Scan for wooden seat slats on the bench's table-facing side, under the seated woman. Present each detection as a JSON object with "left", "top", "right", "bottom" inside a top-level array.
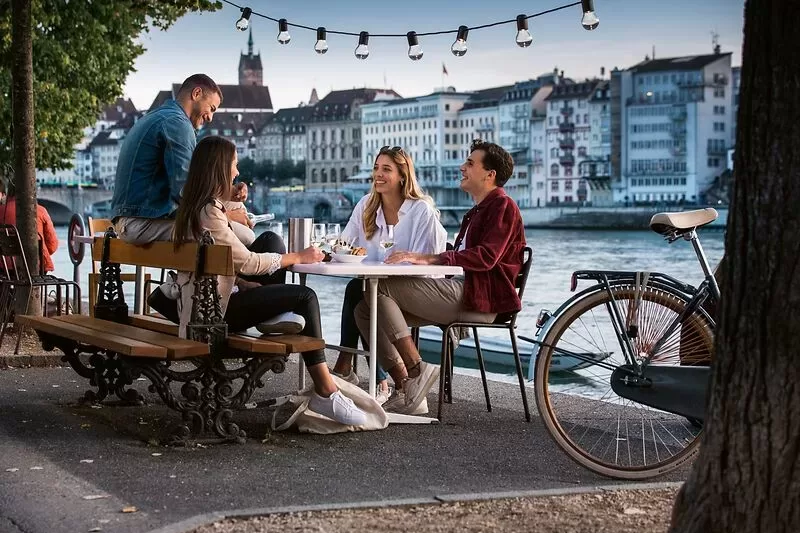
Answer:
[{"left": 131, "top": 315, "right": 325, "bottom": 354}]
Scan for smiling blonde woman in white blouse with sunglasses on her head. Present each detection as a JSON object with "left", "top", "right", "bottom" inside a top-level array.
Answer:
[{"left": 333, "top": 146, "right": 447, "bottom": 403}]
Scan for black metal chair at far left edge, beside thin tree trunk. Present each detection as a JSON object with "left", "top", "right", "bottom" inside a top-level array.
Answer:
[{"left": 0, "top": 224, "right": 81, "bottom": 354}]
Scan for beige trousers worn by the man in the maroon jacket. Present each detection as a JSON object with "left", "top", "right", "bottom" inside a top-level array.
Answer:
[{"left": 355, "top": 277, "right": 497, "bottom": 370}]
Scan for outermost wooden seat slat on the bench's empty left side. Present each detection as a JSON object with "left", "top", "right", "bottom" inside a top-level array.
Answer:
[{"left": 16, "top": 315, "right": 167, "bottom": 359}]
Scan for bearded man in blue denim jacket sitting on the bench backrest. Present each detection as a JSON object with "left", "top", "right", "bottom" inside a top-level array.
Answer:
[{"left": 111, "top": 74, "right": 222, "bottom": 244}]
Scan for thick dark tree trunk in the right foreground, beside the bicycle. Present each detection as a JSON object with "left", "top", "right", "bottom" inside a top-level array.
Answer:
[{"left": 671, "top": 0, "right": 800, "bottom": 533}]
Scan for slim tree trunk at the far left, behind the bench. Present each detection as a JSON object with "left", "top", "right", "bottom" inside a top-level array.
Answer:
[{"left": 11, "top": 0, "right": 39, "bottom": 282}]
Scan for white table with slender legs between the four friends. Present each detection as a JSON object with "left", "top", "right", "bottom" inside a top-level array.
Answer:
[{"left": 289, "top": 261, "right": 464, "bottom": 423}]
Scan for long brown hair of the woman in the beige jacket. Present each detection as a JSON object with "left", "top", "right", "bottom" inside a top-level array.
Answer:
[{"left": 172, "top": 136, "right": 236, "bottom": 246}]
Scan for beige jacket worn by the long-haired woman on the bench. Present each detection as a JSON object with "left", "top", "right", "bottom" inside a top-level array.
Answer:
[{"left": 178, "top": 200, "right": 281, "bottom": 338}]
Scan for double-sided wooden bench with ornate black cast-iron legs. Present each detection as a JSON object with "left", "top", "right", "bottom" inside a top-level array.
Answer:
[{"left": 16, "top": 230, "right": 325, "bottom": 443}]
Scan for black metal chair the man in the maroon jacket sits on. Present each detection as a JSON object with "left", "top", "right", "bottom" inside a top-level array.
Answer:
[{"left": 436, "top": 246, "right": 533, "bottom": 422}]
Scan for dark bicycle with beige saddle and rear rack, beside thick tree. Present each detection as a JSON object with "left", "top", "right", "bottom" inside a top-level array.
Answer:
[{"left": 521, "top": 209, "right": 719, "bottom": 479}]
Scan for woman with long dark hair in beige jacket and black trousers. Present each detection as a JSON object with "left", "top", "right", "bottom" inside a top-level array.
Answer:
[{"left": 173, "top": 136, "right": 366, "bottom": 426}]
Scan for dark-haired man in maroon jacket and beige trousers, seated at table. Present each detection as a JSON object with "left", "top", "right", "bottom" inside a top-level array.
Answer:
[{"left": 355, "top": 140, "right": 525, "bottom": 414}]
